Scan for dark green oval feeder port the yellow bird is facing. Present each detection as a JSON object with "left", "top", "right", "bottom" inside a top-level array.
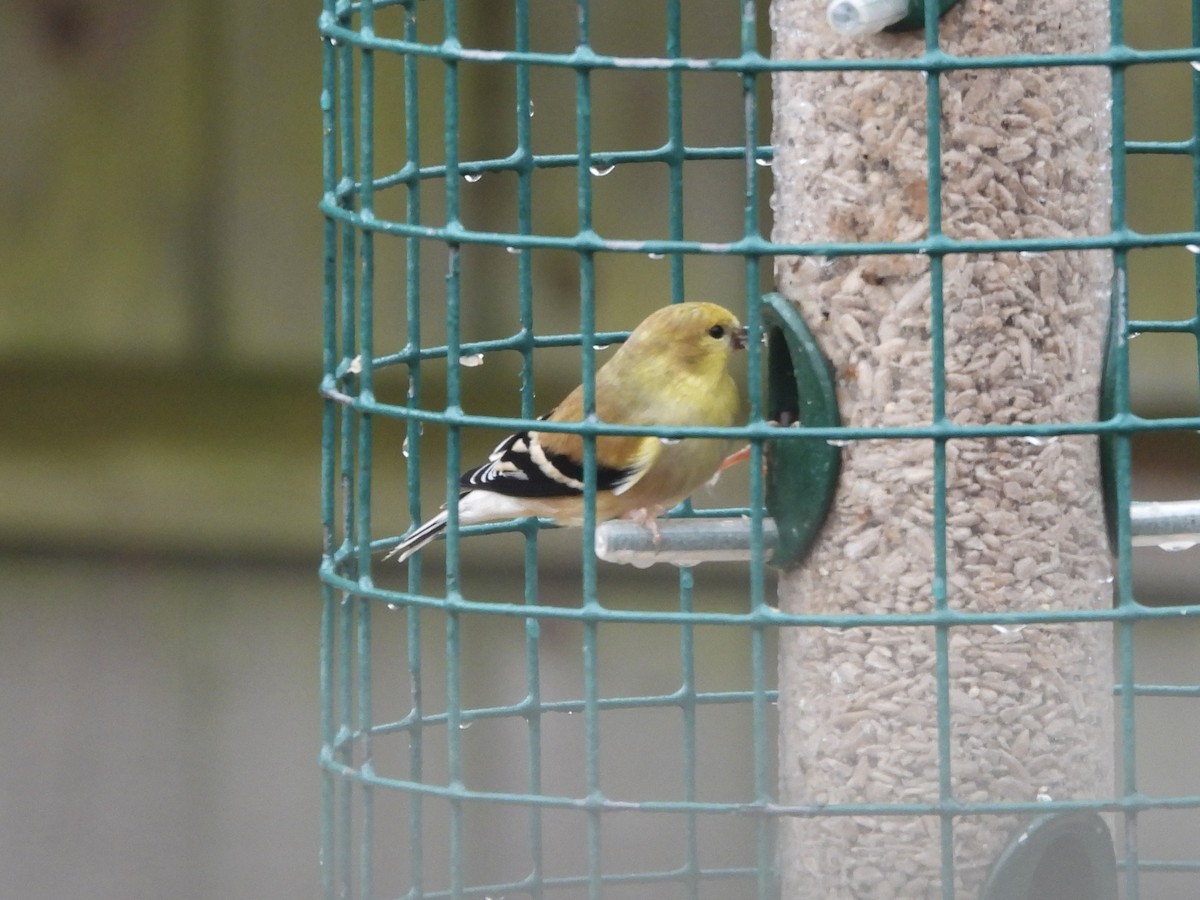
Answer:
[{"left": 762, "top": 294, "right": 841, "bottom": 569}]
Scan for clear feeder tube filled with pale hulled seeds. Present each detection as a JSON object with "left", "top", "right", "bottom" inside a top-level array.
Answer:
[{"left": 772, "top": 0, "right": 1114, "bottom": 898}]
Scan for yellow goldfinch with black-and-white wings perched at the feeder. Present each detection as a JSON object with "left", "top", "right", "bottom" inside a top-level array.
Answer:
[{"left": 388, "top": 302, "right": 746, "bottom": 562}]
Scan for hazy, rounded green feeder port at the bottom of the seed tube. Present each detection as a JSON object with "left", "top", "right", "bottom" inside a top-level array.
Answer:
[{"left": 983, "top": 812, "right": 1117, "bottom": 900}]
